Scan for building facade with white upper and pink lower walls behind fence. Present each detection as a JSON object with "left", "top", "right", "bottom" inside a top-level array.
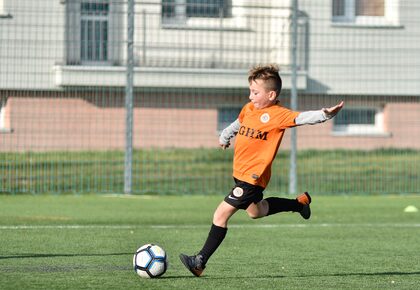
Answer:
[{"left": 0, "top": 0, "right": 420, "bottom": 152}]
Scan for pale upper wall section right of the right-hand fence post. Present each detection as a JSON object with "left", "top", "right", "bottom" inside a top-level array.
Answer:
[{"left": 299, "top": 0, "right": 420, "bottom": 95}]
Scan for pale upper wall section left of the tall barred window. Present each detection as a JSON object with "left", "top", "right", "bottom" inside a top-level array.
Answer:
[{"left": 0, "top": 0, "right": 65, "bottom": 89}]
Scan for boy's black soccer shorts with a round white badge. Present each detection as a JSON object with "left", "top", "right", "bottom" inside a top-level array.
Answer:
[{"left": 224, "top": 178, "right": 264, "bottom": 209}]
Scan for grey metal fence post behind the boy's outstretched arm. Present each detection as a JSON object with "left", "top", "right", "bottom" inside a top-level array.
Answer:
[{"left": 289, "top": 0, "right": 298, "bottom": 194}]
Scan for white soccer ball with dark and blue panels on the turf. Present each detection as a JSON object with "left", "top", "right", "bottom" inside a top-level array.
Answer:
[{"left": 133, "top": 244, "right": 168, "bottom": 278}]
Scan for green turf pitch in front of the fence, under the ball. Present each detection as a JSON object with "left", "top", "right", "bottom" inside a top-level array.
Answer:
[{"left": 0, "top": 195, "right": 420, "bottom": 289}]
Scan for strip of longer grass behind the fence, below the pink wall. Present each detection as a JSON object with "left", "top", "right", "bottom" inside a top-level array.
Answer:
[{"left": 0, "top": 149, "right": 420, "bottom": 194}]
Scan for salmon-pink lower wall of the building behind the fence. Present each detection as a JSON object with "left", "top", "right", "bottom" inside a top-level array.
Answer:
[{"left": 0, "top": 96, "right": 420, "bottom": 152}]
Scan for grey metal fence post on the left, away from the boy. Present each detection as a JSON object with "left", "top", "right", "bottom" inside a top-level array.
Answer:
[{"left": 124, "top": 0, "right": 134, "bottom": 194}]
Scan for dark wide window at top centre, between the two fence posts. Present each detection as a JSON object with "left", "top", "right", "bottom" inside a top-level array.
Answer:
[{"left": 162, "top": 0, "right": 232, "bottom": 23}]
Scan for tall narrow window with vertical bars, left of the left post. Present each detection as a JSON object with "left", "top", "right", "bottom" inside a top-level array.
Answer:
[{"left": 80, "top": 1, "right": 109, "bottom": 62}]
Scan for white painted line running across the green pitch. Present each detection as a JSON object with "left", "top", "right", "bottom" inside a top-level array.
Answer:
[{"left": 0, "top": 223, "right": 420, "bottom": 230}]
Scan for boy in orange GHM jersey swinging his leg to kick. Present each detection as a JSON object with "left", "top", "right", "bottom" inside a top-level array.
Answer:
[{"left": 180, "top": 65, "right": 344, "bottom": 277}]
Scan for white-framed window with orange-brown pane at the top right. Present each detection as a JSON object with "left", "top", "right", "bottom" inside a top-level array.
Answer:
[{"left": 332, "top": 0, "right": 399, "bottom": 25}]
